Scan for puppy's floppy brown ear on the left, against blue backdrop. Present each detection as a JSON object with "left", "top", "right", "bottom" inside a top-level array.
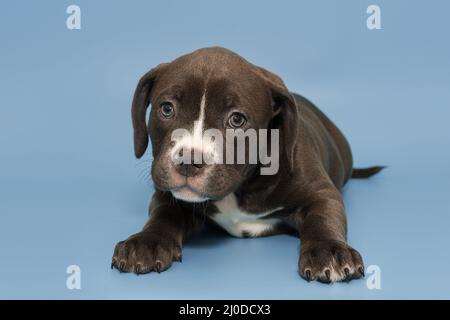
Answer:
[{"left": 131, "top": 64, "right": 166, "bottom": 158}]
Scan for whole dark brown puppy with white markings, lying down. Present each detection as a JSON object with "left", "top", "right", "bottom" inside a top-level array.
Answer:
[{"left": 112, "top": 48, "right": 381, "bottom": 282}]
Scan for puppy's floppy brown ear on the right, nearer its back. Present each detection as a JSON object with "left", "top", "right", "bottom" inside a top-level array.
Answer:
[{"left": 256, "top": 67, "right": 300, "bottom": 173}]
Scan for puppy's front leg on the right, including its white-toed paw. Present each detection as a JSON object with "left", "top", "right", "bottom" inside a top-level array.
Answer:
[{"left": 298, "top": 179, "right": 364, "bottom": 282}]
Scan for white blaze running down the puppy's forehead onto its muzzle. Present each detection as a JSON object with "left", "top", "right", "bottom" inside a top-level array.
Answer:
[{"left": 171, "top": 91, "right": 220, "bottom": 163}]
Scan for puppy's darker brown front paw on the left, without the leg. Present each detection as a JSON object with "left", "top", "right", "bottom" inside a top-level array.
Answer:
[{"left": 111, "top": 232, "right": 181, "bottom": 274}]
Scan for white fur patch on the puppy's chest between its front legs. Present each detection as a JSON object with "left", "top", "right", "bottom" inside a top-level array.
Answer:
[{"left": 211, "top": 194, "right": 282, "bottom": 237}]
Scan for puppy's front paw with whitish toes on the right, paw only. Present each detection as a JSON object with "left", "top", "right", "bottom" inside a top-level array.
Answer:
[{"left": 299, "top": 240, "right": 364, "bottom": 283}]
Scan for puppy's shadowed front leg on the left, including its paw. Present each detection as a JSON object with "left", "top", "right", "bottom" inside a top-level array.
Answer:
[{"left": 111, "top": 191, "right": 203, "bottom": 274}]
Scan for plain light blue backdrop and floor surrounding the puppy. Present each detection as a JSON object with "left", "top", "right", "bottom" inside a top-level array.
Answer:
[{"left": 0, "top": 0, "right": 450, "bottom": 299}]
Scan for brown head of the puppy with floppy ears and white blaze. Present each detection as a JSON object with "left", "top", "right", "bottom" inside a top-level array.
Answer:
[{"left": 132, "top": 48, "right": 298, "bottom": 202}]
